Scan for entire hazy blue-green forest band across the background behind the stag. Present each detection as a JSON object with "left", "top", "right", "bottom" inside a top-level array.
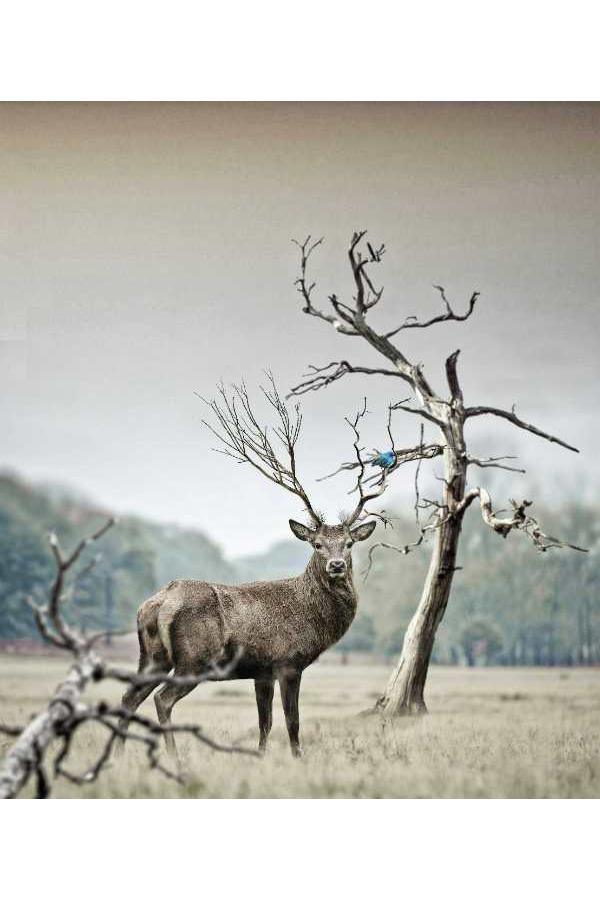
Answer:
[{"left": 0, "top": 474, "right": 600, "bottom": 666}]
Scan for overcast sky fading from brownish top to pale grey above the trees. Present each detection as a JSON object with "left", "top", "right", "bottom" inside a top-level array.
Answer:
[{"left": 0, "top": 103, "right": 600, "bottom": 554}]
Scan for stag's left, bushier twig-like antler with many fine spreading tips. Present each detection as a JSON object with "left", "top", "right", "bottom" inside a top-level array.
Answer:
[{"left": 197, "top": 372, "right": 323, "bottom": 526}]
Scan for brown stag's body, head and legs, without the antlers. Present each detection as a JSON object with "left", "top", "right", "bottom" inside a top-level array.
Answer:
[{"left": 123, "top": 521, "right": 374, "bottom": 755}]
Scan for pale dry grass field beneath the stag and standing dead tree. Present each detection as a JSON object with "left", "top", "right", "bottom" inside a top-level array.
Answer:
[{"left": 0, "top": 655, "right": 600, "bottom": 798}]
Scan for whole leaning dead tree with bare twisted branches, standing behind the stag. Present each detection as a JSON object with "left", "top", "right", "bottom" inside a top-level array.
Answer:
[{"left": 291, "top": 231, "right": 582, "bottom": 715}]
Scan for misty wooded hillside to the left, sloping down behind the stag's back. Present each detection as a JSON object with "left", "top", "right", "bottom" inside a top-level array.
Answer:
[{"left": 0, "top": 475, "right": 236, "bottom": 640}]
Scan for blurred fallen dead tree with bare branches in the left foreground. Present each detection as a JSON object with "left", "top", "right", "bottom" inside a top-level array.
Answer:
[{"left": 0, "top": 519, "right": 254, "bottom": 800}]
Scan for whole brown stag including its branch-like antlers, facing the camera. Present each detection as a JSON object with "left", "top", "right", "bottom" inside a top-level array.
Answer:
[{"left": 122, "top": 377, "right": 387, "bottom": 756}]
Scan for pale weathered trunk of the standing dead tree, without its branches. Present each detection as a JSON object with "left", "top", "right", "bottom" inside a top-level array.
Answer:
[{"left": 375, "top": 420, "right": 466, "bottom": 716}]
